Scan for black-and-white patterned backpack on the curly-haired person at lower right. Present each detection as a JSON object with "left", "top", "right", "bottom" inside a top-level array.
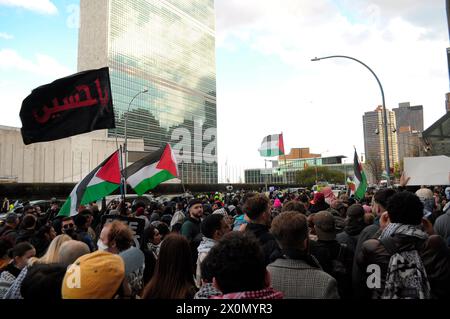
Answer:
[{"left": 380, "top": 239, "right": 431, "bottom": 299}]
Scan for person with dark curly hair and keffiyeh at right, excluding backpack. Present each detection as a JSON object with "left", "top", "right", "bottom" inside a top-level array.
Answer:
[{"left": 355, "top": 191, "right": 450, "bottom": 299}]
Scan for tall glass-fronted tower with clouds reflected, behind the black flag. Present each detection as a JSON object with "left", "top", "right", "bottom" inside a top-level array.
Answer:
[{"left": 78, "top": 0, "right": 217, "bottom": 183}]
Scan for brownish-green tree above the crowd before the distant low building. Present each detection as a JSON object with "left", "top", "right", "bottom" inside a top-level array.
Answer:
[{"left": 296, "top": 166, "right": 345, "bottom": 187}]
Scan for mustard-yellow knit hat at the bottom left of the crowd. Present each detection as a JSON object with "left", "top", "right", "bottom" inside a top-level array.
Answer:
[{"left": 62, "top": 251, "right": 125, "bottom": 299}]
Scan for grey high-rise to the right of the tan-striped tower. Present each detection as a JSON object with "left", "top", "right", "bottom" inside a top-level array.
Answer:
[{"left": 393, "top": 102, "right": 423, "bottom": 161}]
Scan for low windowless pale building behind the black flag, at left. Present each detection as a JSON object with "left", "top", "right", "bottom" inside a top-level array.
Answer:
[{"left": 0, "top": 125, "right": 144, "bottom": 183}]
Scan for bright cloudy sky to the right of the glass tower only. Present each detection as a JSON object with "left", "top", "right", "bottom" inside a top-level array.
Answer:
[{"left": 216, "top": 0, "right": 449, "bottom": 178}]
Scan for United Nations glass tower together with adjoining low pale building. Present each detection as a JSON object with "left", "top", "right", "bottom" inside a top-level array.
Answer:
[{"left": 0, "top": 0, "right": 218, "bottom": 184}]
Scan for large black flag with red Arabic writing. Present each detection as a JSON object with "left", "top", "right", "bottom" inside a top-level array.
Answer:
[{"left": 20, "top": 67, "right": 116, "bottom": 145}]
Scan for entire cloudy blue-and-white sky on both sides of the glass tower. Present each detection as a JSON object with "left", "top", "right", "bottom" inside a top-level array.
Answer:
[{"left": 0, "top": 0, "right": 449, "bottom": 179}]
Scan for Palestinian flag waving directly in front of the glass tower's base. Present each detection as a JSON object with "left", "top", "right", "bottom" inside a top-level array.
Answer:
[{"left": 124, "top": 144, "right": 178, "bottom": 196}]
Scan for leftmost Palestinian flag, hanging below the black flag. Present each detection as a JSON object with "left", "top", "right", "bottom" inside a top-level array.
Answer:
[{"left": 58, "top": 151, "right": 120, "bottom": 216}]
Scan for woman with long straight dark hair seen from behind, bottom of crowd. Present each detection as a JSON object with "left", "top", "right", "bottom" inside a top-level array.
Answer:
[{"left": 143, "top": 234, "right": 196, "bottom": 299}]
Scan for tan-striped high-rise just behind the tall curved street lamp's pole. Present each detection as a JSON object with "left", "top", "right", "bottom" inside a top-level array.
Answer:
[{"left": 363, "top": 106, "right": 399, "bottom": 179}]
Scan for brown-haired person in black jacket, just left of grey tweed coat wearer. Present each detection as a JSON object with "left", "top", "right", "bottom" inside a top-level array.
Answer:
[{"left": 244, "top": 194, "right": 283, "bottom": 265}]
